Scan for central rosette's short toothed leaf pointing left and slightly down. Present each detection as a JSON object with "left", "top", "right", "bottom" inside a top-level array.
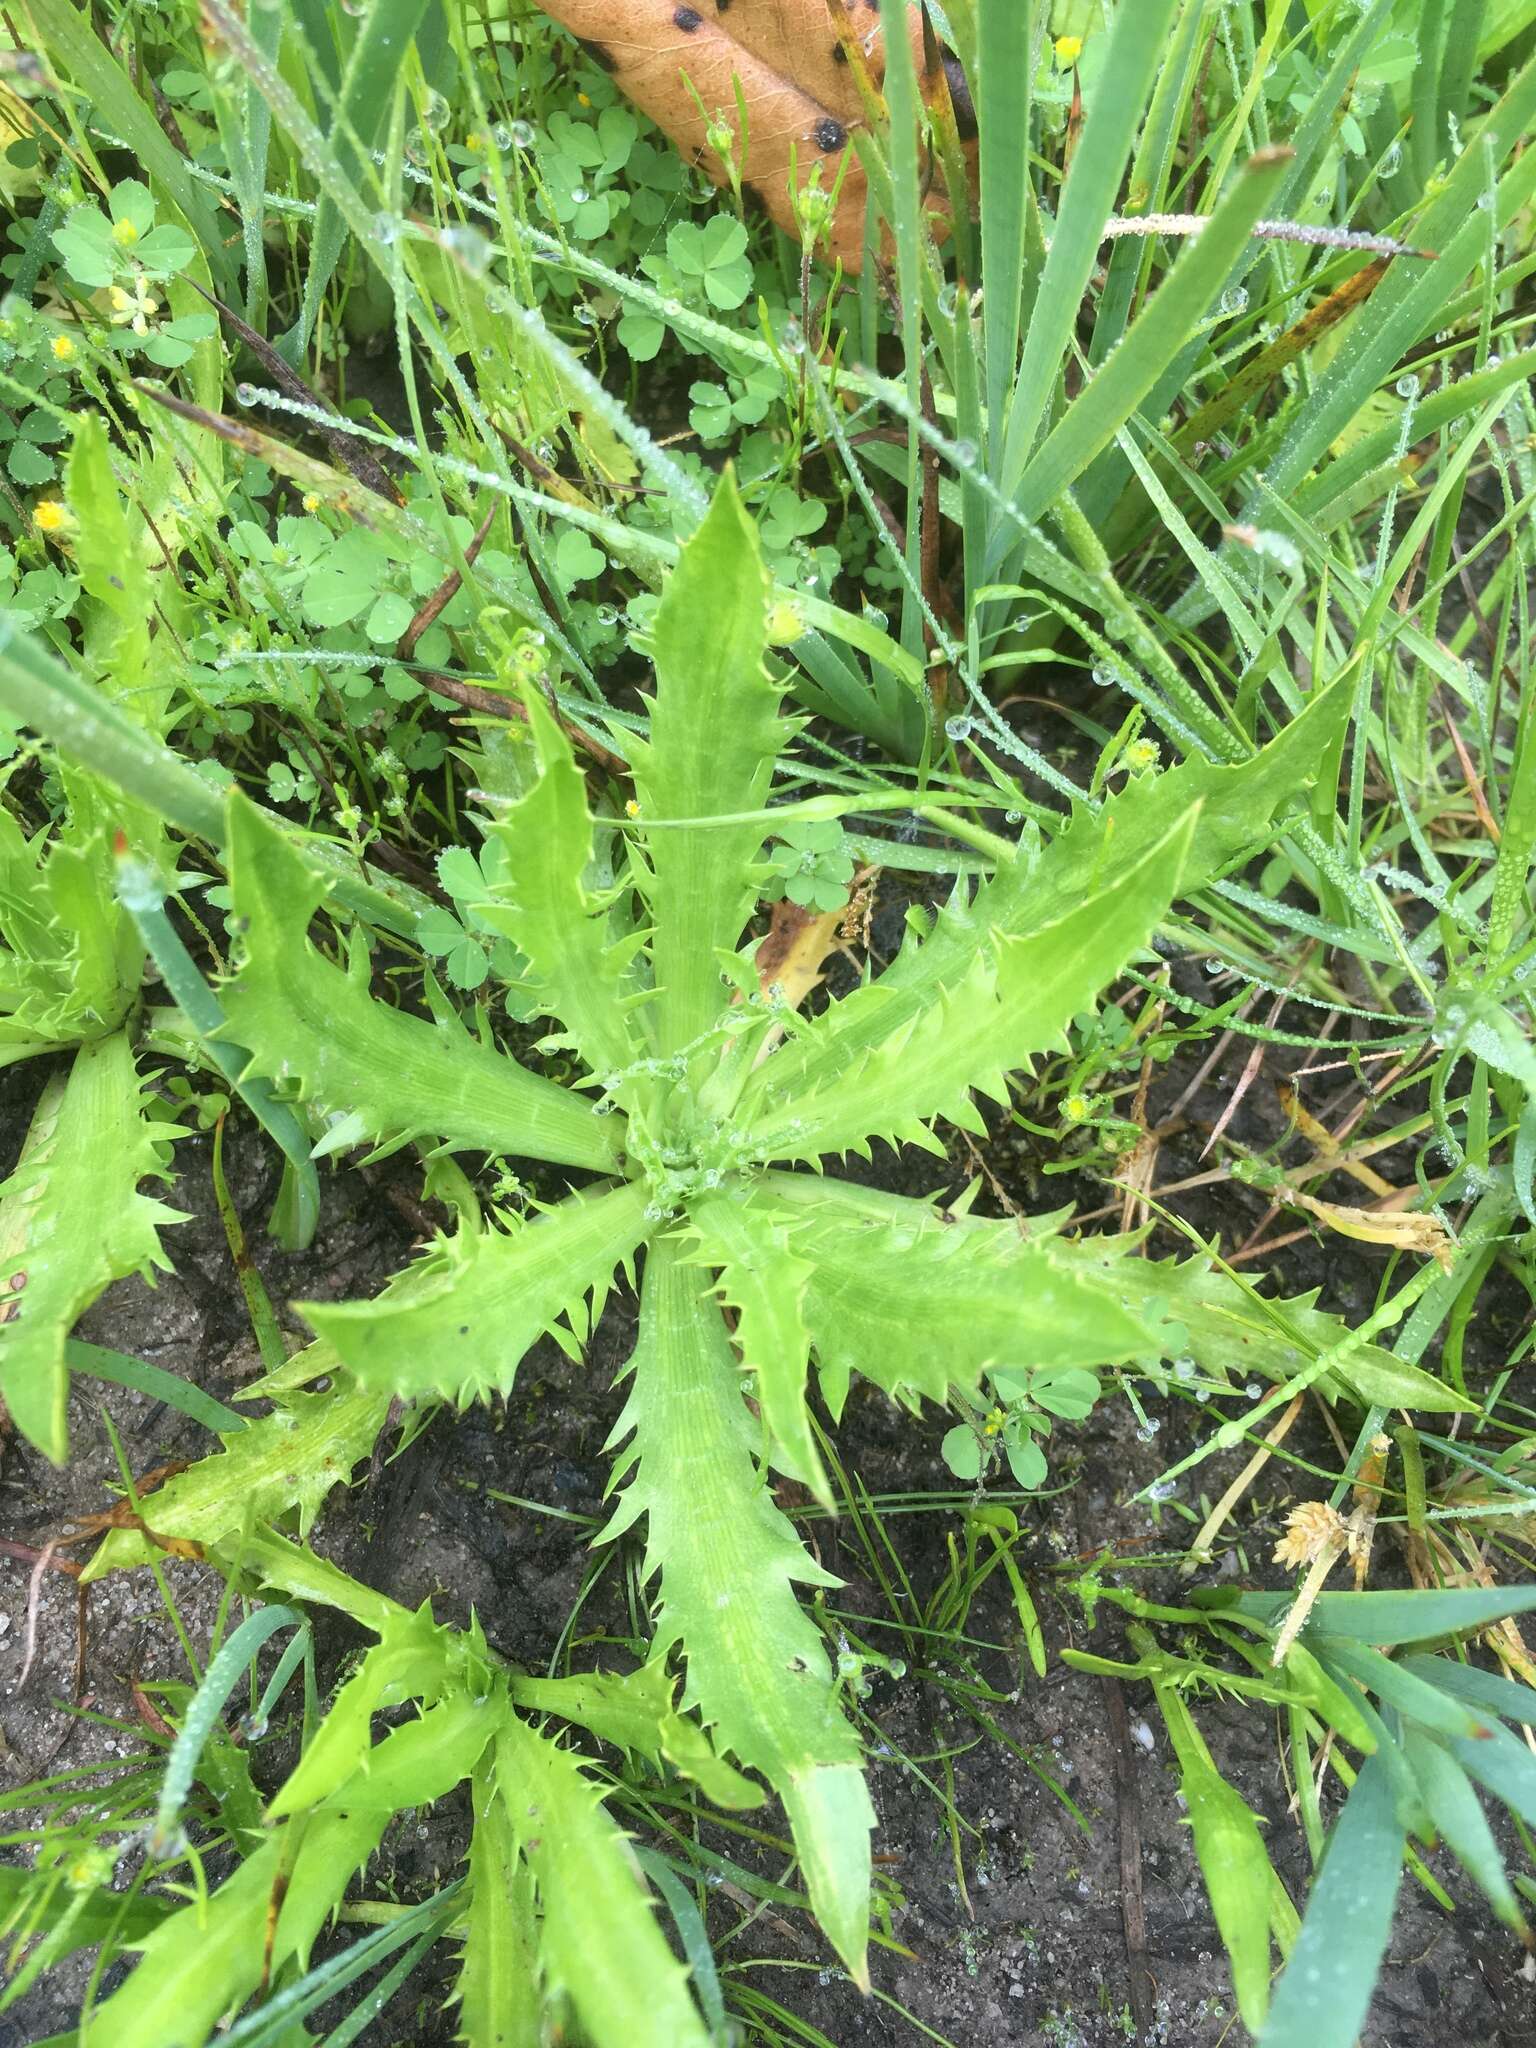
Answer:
[{"left": 299, "top": 1184, "right": 649, "bottom": 1407}]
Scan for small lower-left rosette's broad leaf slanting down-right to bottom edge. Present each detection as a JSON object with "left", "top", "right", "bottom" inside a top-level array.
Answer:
[{"left": 496, "top": 1716, "right": 711, "bottom": 2048}]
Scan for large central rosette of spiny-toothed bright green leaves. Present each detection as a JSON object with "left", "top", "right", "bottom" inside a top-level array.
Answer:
[{"left": 98, "top": 479, "right": 1458, "bottom": 1980}]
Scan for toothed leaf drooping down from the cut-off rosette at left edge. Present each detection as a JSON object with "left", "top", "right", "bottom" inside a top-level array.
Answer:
[{"left": 0, "top": 1032, "right": 184, "bottom": 1464}]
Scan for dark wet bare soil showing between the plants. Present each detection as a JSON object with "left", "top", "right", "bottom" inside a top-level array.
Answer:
[{"left": 0, "top": 950, "right": 1536, "bottom": 2048}]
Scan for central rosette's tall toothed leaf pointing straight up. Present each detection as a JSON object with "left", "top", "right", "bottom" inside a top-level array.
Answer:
[{"left": 631, "top": 475, "right": 793, "bottom": 1053}]
